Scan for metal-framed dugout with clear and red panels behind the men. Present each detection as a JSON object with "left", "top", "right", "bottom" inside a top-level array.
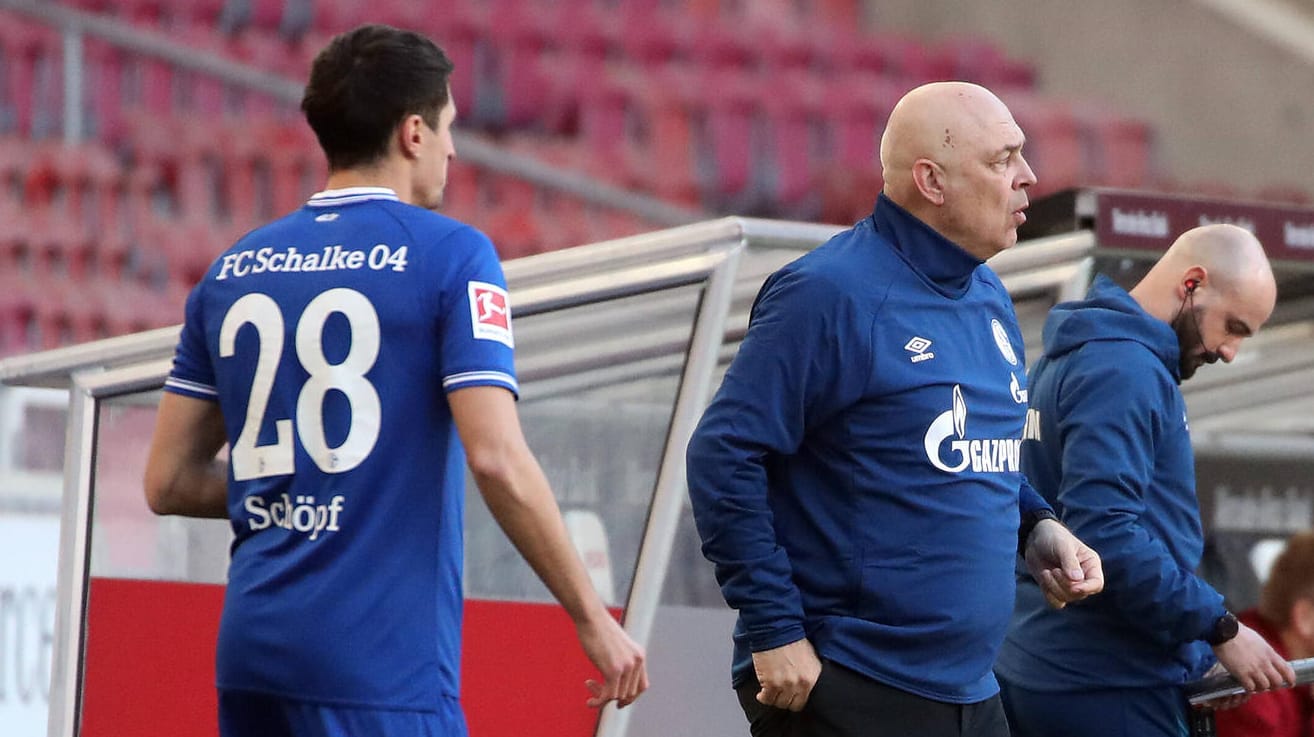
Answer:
[{"left": 0, "top": 195, "right": 1314, "bottom": 737}]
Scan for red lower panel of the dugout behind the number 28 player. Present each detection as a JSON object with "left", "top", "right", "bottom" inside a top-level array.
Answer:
[{"left": 81, "top": 578, "right": 618, "bottom": 737}]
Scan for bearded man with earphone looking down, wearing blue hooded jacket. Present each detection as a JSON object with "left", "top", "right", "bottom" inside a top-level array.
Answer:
[{"left": 996, "top": 225, "right": 1296, "bottom": 737}]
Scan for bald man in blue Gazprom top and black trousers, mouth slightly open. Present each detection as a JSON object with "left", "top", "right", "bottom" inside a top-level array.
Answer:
[{"left": 687, "top": 83, "right": 1102, "bottom": 737}]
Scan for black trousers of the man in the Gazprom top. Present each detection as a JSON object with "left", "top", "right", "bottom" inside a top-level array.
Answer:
[{"left": 738, "top": 661, "right": 1009, "bottom": 737}]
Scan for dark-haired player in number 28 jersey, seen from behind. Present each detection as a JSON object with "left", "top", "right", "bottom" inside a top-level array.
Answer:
[{"left": 145, "top": 25, "right": 648, "bottom": 737}]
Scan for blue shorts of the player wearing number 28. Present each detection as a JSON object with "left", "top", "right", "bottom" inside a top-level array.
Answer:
[{"left": 219, "top": 688, "right": 468, "bottom": 737}]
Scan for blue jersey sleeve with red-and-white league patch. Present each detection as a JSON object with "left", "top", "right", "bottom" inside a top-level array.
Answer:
[{"left": 438, "top": 227, "right": 520, "bottom": 397}]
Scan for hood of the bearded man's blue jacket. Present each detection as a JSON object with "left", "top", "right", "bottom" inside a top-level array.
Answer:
[{"left": 1045, "top": 275, "right": 1181, "bottom": 384}]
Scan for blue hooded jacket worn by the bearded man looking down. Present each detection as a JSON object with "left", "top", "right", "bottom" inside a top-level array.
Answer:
[{"left": 997, "top": 276, "right": 1225, "bottom": 691}]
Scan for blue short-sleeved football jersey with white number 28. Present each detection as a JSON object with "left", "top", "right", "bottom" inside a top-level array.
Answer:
[{"left": 164, "top": 188, "right": 518, "bottom": 709}]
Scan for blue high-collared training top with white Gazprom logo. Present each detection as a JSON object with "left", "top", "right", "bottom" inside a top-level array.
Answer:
[{"left": 687, "top": 196, "right": 1046, "bottom": 703}]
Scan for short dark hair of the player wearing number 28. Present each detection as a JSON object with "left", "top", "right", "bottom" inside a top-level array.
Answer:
[{"left": 301, "top": 25, "right": 452, "bottom": 171}]
